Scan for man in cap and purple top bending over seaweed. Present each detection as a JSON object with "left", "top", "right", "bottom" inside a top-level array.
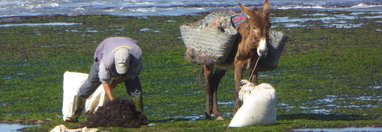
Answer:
[{"left": 65, "top": 37, "right": 143, "bottom": 122}]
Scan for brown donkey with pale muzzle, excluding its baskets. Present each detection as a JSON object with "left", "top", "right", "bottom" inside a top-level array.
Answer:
[{"left": 202, "top": 0, "right": 271, "bottom": 120}]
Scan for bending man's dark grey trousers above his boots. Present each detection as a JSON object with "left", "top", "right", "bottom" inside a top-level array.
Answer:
[{"left": 78, "top": 62, "right": 142, "bottom": 98}]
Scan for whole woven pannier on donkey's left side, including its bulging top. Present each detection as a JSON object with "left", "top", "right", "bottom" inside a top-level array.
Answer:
[{"left": 180, "top": 11, "right": 238, "bottom": 65}]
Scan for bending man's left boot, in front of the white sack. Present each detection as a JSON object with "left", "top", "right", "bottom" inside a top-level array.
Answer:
[{"left": 65, "top": 95, "right": 86, "bottom": 122}]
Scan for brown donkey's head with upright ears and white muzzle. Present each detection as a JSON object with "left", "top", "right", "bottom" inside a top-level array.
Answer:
[{"left": 239, "top": 0, "right": 271, "bottom": 57}]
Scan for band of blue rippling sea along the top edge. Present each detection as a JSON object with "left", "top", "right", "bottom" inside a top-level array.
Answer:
[{"left": 0, "top": 0, "right": 382, "bottom": 18}]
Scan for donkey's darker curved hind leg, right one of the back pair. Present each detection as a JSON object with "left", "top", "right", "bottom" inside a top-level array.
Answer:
[{"left": 211, "top": 69, "right": 226, "bottom": 120}]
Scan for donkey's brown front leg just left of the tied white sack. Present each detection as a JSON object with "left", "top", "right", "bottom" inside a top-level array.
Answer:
[{"left": 233, "top": 60, "right": 244, "bottom": 115}]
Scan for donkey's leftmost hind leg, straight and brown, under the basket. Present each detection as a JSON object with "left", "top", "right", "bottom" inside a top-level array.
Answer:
[{"left": 203, "top": 65, "right": 213, "bottom": 119}]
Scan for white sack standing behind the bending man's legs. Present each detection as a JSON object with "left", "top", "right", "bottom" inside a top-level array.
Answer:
[{"left": 62, "top": 71, "right": 108, "bottom": 120}]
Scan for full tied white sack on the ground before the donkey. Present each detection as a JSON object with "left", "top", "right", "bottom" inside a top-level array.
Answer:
[{"left": 229, "top": 80, "right": 276, "bottom": 127}]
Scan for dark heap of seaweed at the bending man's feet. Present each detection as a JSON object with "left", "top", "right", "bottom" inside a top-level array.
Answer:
[{"left": 83, "top": 99, "right": 148, "bottom": 128}]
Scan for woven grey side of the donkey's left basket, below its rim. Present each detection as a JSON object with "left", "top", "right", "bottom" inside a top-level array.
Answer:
[{"left": 180, "top": 25, "right": 237, "bottom": 65}]
